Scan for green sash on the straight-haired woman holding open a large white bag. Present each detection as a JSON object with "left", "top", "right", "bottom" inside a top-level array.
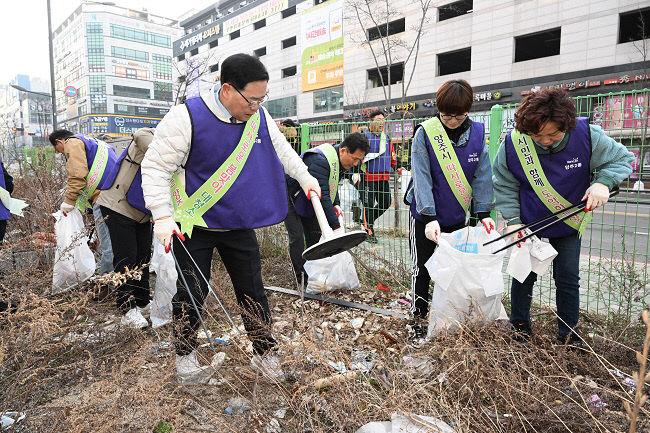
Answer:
[{"left": 422, "top": 117, "right": 472, "bottom": 212}]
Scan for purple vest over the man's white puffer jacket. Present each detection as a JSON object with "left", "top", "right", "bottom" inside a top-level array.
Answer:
[{"left": 185, "top": 97, "right": 288, "bottom": 230}]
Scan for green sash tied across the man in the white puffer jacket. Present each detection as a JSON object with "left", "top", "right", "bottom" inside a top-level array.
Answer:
[{"left": 171, "top": 111, "right": 260, "bottom": 237}]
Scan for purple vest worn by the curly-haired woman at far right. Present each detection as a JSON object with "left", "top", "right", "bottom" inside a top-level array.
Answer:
[{"left": 505, "top": 117, "right": 591, "bottom": 238}]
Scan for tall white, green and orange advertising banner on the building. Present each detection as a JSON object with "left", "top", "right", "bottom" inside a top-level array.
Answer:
[{"left": 300, "top": 0, "right": 343, "bottom": 92}]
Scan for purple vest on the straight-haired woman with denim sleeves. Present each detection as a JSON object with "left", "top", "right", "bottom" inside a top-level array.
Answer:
[{"left": 410, "top": 121, "right": 485, "bottom": 227}]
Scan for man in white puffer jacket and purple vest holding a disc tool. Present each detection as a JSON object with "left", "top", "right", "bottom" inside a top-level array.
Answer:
[{"left": 142, "top": 54, "right": 320, "bottom": 384}]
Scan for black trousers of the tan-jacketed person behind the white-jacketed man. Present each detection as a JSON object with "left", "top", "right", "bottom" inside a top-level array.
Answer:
[{"left": 100, "top": 206, "right": 152, "bottom": 314}]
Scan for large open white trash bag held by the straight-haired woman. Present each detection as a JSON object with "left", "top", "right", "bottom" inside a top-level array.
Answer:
[{"left": 425, "top": 226, "right": 508, "bottom": 338}]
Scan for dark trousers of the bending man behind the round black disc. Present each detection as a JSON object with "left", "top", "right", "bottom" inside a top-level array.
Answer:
[{"left": 284, "top": 197, "right": 321, "bottom": 284}]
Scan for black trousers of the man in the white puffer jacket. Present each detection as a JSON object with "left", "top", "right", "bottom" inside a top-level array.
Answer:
[{"left": 172, "top": 228, "right": 275, "bottom": 355}]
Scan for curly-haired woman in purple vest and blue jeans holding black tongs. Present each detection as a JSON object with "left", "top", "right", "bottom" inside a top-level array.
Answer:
[{"left": 494, "top": 89, "right": 634, "bottom": 346}]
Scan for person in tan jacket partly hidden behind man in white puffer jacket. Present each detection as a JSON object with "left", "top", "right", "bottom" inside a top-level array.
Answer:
[{"left": 96, "top": 128, "right": 154, "bottom": 329}]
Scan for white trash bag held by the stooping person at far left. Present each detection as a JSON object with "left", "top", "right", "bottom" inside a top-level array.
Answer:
[{"left": 52, "top": 208, "right": 95, "bottom": 294}]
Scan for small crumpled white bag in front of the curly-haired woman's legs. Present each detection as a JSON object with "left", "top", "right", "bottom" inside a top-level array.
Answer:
[{"left": 506, "top": 236, "right": 557, "bottom": 283}]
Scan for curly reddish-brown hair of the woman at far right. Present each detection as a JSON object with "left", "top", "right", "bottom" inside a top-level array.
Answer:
[{"left": 515, "top": 88, "right": 576, "bottom": 134}]
